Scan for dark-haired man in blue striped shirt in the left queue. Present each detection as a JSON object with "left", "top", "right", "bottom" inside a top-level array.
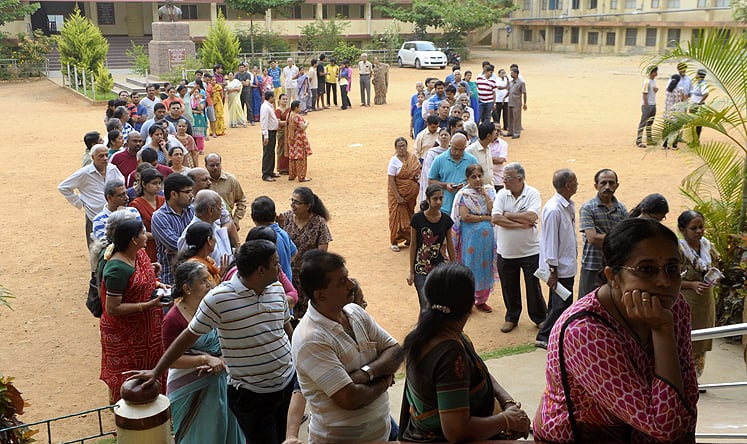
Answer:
[{"left": 150, "top": 174, "right": 195, "bottom": 285}]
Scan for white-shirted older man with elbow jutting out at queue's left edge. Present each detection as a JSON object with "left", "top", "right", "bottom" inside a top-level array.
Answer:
[{"left": 57, "top": 144, "right": 124, "bottom": 246}]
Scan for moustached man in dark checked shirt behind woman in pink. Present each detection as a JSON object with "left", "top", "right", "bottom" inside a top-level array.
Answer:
[{"left": 580, "top": 168, "right": 628, "bottom": 297}]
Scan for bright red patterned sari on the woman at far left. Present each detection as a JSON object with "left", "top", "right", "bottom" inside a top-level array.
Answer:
[{"left": 99, "top": 248, "right": 166, "bottom": 404}]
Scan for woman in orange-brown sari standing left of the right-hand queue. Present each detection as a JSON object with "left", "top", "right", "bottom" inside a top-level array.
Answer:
[{"left": 387, "top": 137, "right": 420, "bottom": 252}]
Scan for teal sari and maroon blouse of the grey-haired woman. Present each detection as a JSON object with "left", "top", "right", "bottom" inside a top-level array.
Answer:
[{"left": 163, "top": 309, "right": 245, "bottom": 444}]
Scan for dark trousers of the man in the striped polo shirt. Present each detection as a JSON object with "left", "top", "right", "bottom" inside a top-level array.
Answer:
[{"left": 228, "top": 376, "right": 296, "bottom": 444}]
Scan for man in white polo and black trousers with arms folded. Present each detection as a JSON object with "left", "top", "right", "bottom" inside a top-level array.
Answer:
[{"left": 493, "top": 162, "right": 547, "bottom": 333}]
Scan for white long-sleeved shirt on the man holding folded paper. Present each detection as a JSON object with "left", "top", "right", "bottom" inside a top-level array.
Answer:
[{"left": 539, "top": 193, "right": 578, "bottom": 278}]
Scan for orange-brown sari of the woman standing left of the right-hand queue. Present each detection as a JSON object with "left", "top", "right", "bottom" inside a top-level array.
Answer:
[{"left": 387, "top": 151, "right": 420, "bottom": 245}]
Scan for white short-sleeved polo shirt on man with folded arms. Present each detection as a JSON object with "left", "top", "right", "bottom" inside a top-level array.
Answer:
[{"left": 493, "top": 183, "right": 542, "bottom": 259}]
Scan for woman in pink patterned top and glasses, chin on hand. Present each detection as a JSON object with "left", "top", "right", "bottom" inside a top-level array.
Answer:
[{"left": 534, "top": 218, "right": 698, "bottom": 443}]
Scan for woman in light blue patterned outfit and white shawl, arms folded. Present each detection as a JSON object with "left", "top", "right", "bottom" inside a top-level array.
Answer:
[{"left": 451, "top": 163, "right": 497, "bottom": 313}]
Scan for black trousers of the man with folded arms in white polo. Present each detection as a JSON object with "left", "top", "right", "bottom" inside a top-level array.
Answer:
[{"left": 497, "top": 254, "right": 547, "bottom": 324}]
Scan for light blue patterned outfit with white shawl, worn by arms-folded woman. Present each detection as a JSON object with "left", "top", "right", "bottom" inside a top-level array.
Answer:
[{"left": 451, "top": 185, "right": 498, "bottom": 304}]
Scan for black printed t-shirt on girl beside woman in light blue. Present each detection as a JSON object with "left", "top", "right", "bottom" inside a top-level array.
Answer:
[{"left": 410, "top": 211, "right": 454, "bottom": 276}]
